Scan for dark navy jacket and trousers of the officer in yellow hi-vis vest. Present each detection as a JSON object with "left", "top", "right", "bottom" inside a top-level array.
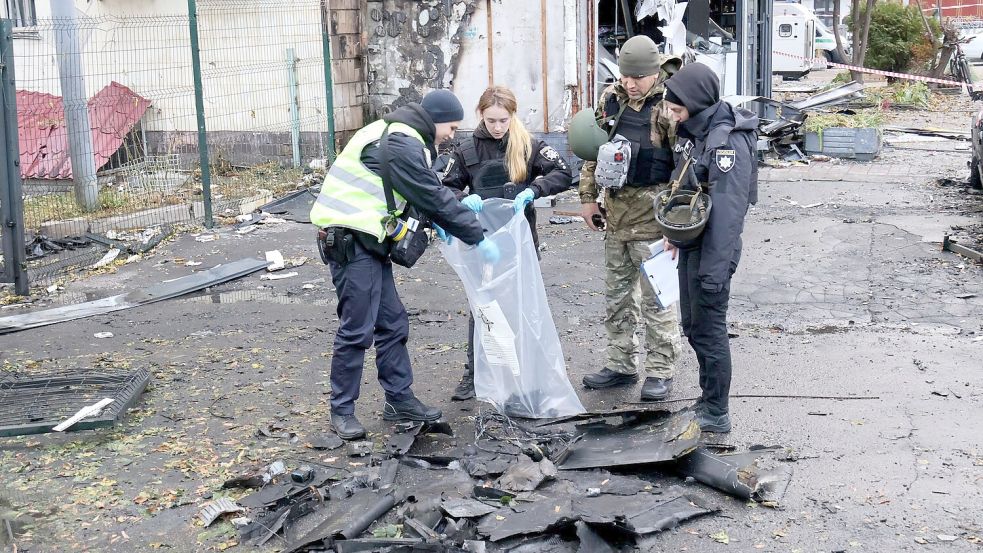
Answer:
[{"left": 326, "top": 104, "right": 484, "bottom": 415}]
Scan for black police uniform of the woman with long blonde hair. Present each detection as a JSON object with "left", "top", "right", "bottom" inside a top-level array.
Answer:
[{"left": 444, "top": 122, "right": 573, "bottom": 372}]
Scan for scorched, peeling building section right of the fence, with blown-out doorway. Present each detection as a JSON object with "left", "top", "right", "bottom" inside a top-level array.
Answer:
[{"left": 361, "top": 0, "right": 772, "bottom": 147}]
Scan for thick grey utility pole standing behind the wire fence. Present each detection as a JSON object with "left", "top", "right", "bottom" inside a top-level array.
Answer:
[{"left": 51, "top": 0, "right": 99, "bottom": 211}]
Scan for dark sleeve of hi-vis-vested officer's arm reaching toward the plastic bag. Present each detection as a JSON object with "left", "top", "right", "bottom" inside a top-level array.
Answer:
[{"left": 388, "top": 133, "right": 484, "bottom": 245}]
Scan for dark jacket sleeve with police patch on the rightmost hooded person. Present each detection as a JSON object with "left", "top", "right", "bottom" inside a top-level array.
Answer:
[{"left": 699, "top": 132, "right": 756, "bottom": 292}]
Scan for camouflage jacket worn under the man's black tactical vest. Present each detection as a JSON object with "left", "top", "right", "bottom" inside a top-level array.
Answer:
[{"left": 579, "top": 79, "right": 676, "bottom": 241}]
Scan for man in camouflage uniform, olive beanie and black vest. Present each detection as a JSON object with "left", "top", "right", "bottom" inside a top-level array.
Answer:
[{"left": 580, "top": 35, "right": 680, "bottom": 401}]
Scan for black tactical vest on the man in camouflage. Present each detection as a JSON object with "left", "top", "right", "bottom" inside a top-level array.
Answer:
[{"left": 604, "top": 94, "right": 673, "bottom": 183}]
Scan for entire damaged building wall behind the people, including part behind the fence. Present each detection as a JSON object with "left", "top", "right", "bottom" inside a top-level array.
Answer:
[{"left": 7, "top": 0, "right": 771, "bottom": 167}]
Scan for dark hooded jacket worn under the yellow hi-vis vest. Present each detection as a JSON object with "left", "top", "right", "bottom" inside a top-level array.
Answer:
[{"left": 361, "top": 103, "right": 484, "bottom": 245}]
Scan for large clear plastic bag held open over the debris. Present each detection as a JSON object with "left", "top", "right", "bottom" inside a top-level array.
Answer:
[{"left": 440, "top": 199, "right": 584, "bottom": 418}]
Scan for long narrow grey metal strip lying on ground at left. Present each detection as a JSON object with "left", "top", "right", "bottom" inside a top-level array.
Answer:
[{"left": 0, "top": 258, "right": 268, "bottom": 334}]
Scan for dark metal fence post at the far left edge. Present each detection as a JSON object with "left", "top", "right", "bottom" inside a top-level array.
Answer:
[{"left": 0, "top": 19, "right": 30, "bottom": 296}]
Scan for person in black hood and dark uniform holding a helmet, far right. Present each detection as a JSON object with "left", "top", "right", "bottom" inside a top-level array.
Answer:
[{"left": 665, "top": 63, "right": 758, "bottom": 432}]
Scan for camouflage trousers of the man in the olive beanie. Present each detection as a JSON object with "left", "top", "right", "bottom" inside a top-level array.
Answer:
[{"left": 604, "top": 234, "right": 680, "bottom": 378}]
